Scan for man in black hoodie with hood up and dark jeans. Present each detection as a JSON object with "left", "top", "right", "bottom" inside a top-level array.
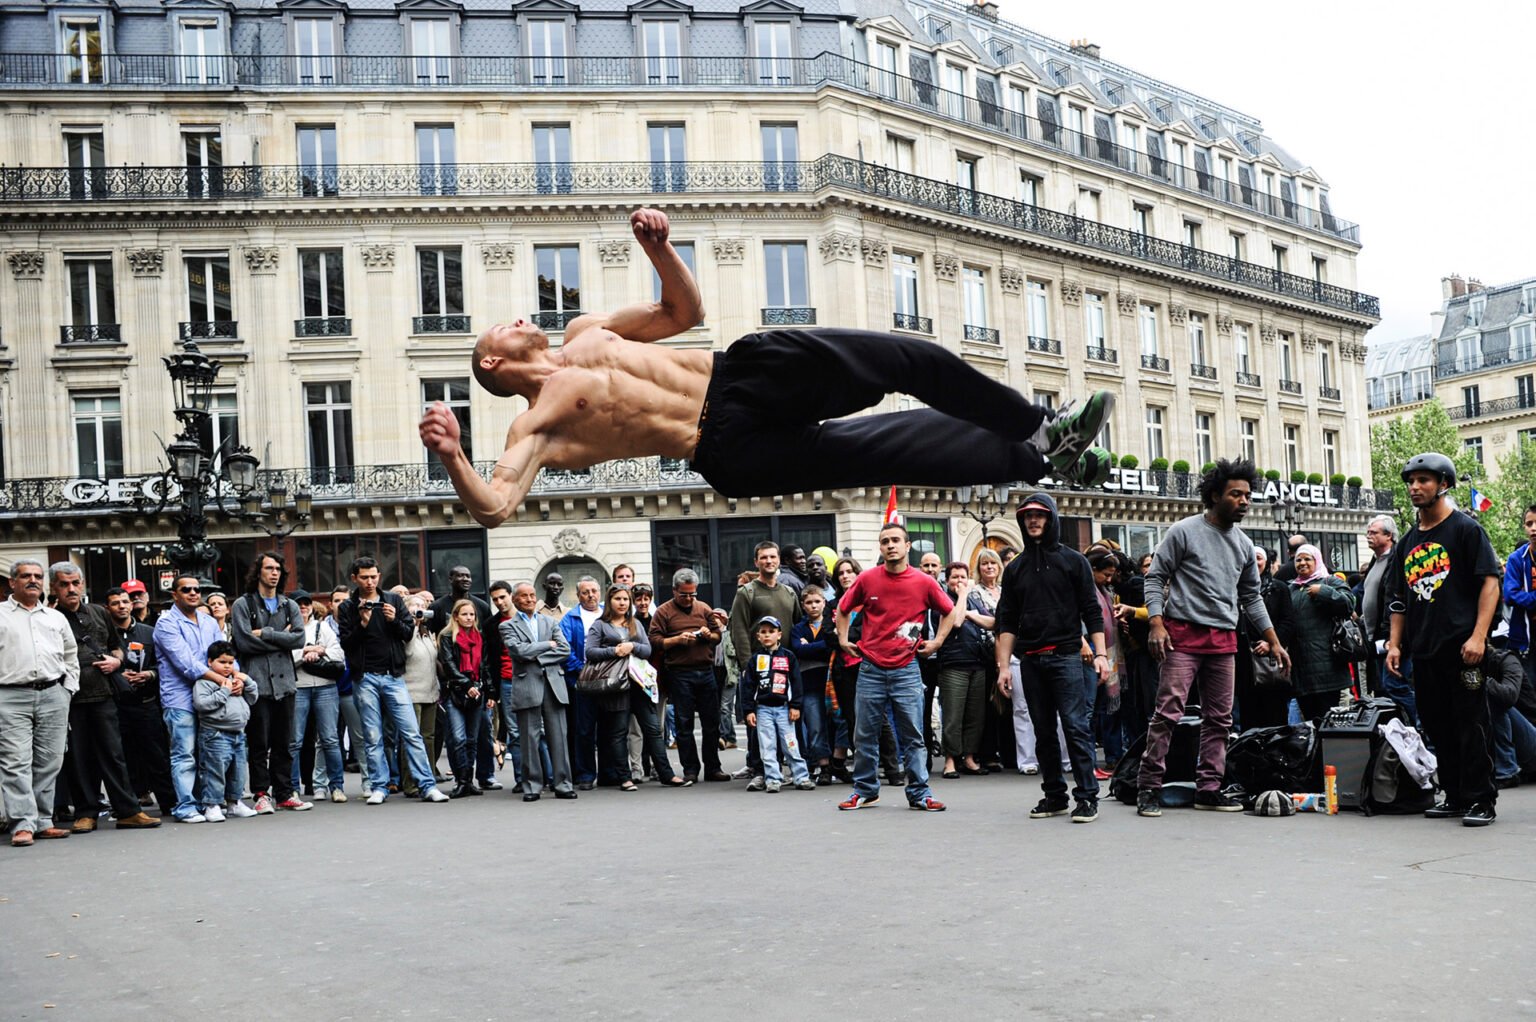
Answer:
[{"left": 997, "top": 493, "right": 1109, "bottom": 824}]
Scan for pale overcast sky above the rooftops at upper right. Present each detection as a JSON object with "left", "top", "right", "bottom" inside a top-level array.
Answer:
[{"left": 998, "top": 0, "right": 1536, "bottom": 341}]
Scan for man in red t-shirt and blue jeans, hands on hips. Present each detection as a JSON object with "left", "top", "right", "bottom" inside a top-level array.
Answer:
[{"left": 837, "top": 523, "right": 954, "bottom": 813}]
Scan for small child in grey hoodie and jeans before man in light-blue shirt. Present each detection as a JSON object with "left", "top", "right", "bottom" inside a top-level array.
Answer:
[{"left": 192, "top": 641, "right": 257, "bottom": 824}]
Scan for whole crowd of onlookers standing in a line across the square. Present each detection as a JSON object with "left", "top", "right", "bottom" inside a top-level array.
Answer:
[{"left": 0, "top": 455, "right": 1536, "bottom": 847}]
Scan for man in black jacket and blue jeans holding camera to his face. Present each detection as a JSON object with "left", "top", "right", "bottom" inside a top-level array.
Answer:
[{"left": 336, "top": 556, "right": 449, "bottom": 805}]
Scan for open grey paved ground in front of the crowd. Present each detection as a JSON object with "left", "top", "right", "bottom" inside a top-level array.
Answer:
[{"left": 0, "top": 740, "right": 1536, "bottom": 1022}]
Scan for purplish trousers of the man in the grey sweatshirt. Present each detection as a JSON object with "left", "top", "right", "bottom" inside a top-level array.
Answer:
[{"left": 1137, "top": 650, "right": 1236, "bottom": 791}]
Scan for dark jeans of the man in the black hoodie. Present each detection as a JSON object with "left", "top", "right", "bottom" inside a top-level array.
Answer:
[{"left": 1018, "top": 647, "right": 1098, "bottom": 802}]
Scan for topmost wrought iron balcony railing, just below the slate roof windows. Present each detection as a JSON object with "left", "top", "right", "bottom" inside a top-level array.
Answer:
[{"left": 0, "top": 52, "right": 1359, "bottom": 244}]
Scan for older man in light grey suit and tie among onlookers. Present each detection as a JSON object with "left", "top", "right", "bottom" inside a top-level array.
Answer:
[{"left": 501, "top": 582, "right": 576, "bottom": 802}]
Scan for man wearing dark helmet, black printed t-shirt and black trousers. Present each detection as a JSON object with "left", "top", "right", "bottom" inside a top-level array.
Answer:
[{"left": 1387, "top": 452, "right": 1499, "bottom": 827}]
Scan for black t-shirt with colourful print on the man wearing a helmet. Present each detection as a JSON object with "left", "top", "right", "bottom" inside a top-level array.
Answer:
[{"left": 1390, "top": 510, "right": 1499, "bottom": 658}]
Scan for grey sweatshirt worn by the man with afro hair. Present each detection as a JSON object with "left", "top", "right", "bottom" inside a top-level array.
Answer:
[{"left": 1146, "top": 515, "right": 1270, "bottom": 633}]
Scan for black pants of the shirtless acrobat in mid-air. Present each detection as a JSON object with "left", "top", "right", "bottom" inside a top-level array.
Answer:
[{"left": 693, "top": 329, "right": 1046, "bottom": 496}]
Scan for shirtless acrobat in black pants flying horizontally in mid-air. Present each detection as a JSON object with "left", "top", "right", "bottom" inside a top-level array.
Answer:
[{"left": 421, "top": 209, "right": 1114, "bottom": 527}]
